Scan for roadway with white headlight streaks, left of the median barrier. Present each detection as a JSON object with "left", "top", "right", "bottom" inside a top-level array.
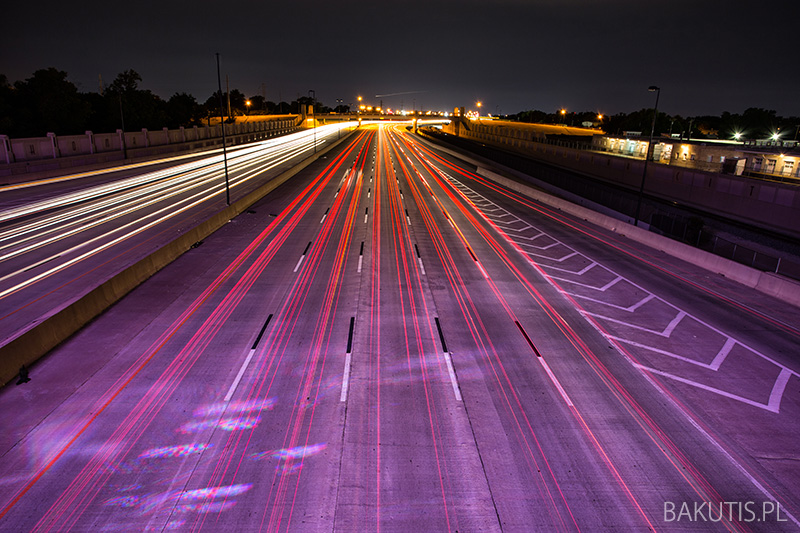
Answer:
[{"left": 0, "top": 124, "right": 350, "bottom": 350}]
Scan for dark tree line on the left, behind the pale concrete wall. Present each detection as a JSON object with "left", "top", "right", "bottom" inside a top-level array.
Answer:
[{"left": 0, "top": 67, "right": 349, "bottom": 138}]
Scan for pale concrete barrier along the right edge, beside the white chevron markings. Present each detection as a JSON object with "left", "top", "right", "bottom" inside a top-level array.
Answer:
[{"left": 418, "top": 132, "right": 800, "bottom": 307}]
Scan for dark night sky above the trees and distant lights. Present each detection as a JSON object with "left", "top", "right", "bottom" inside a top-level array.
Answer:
[{"left": 6, "top": 0, "right": 800, "bottom": 116}]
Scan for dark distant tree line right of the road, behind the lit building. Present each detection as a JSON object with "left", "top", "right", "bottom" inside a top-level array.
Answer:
[{"left": 508, "top": 107, "right": 800, "bottom": 140}]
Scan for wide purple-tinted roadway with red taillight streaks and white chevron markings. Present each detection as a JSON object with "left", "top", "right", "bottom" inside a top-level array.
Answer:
[{"left": 0, "top": 125, "right": 800, "bottom": 532}]
